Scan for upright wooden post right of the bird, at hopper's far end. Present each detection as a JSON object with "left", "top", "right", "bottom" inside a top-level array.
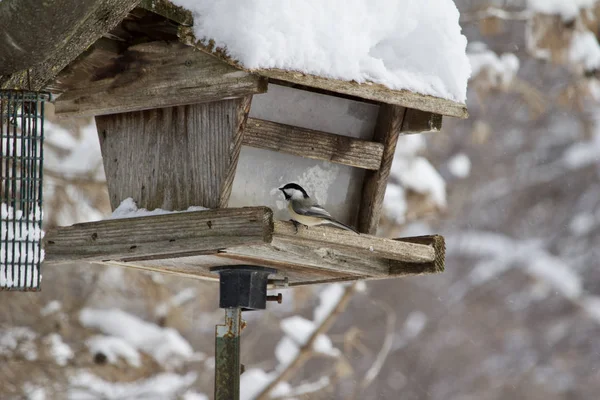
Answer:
[{"left": 358, "top": 104, "right": 406, "bottom": 235}]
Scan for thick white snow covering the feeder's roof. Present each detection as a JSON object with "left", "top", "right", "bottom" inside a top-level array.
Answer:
[{"left": 173, "top": 0, "right": 470, "bottom": 103}]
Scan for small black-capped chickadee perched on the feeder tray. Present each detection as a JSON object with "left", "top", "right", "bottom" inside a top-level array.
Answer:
[{"left": 279, "top": 183, "right": 358, "bottom": 233}]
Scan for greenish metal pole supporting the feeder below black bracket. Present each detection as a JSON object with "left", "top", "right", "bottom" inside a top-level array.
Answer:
[{"left": 215, "top": 307, "right": 242, "bottom": 400}]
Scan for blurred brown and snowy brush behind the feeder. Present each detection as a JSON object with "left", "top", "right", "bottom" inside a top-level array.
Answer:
[{"left": 0, "top": 0, "right": 600, "bottom": 400}]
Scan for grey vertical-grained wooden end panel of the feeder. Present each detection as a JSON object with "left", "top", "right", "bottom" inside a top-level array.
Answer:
[{"left": 96, "top": 98, "right": 249, "bottom": 210}]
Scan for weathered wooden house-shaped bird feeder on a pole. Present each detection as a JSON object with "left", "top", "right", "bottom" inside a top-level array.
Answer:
[{"left": 8, "top": 0, "right": 467, "bottom": 286}]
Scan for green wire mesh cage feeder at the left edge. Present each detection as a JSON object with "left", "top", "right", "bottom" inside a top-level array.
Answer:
[{"left": 0, "top": 90, "right": 50, "bottom": 291}]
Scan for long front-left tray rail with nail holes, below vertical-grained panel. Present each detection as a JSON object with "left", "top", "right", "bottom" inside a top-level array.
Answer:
[{"left": 44, "top": 207, "right": 273, "bottom": 263}]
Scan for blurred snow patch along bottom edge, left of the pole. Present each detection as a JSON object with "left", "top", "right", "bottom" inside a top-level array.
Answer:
[{"left": 67, "top": 371, "right": 197, "bottom": 400}]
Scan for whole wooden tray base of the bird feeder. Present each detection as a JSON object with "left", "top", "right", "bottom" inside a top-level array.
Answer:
[{"left": 44, "top": 207, "right": 445, "bottom": 286}]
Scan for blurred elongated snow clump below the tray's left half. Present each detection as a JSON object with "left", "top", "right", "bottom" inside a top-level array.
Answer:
[{"left": 79, "top": 308, "right": 194, "bottom": 369}]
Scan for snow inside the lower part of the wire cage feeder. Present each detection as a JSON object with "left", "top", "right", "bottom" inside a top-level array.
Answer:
[{"left": 0, "top": 203, "right": 44, "bottom": 288}]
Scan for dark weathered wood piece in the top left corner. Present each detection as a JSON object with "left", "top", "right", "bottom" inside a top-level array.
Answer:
[{"left": 0, "top": 0, "right": 139, "bottom": 90}]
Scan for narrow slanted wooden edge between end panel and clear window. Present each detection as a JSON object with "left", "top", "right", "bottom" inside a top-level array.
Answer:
[{"left": 219, "top": 96, "right": 252, "bottom": 208}]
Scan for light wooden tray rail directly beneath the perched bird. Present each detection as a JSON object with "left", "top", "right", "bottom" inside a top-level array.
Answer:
[{"left": 273, "top": 221, "right": 436, "bottom": 263}]
